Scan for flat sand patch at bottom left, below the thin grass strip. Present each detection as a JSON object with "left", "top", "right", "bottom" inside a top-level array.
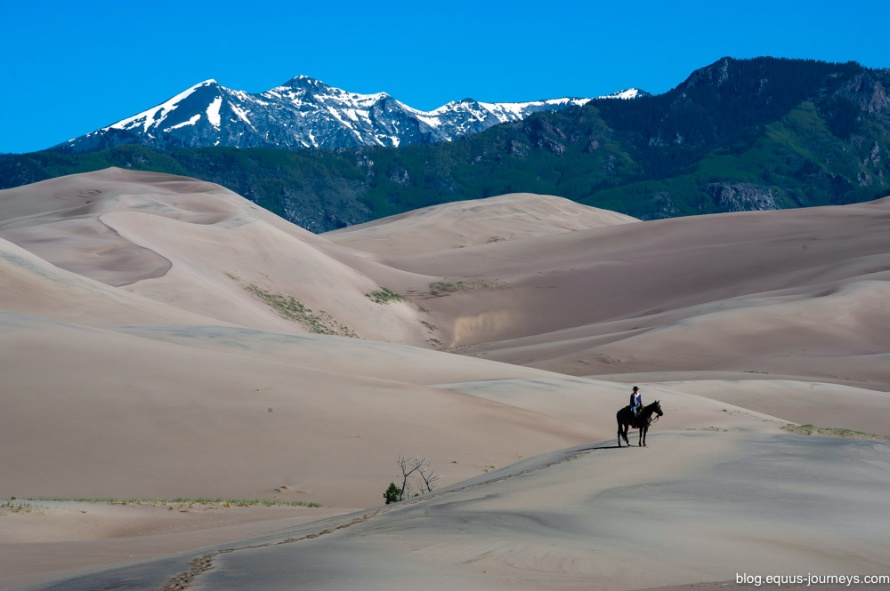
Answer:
[{"left": 0, "top": 501, "right": 342, "bottom": 589}]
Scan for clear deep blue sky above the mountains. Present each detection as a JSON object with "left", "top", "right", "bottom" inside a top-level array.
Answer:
[{"left": 0, "top": 0, "right": 890, "bottom": 153}]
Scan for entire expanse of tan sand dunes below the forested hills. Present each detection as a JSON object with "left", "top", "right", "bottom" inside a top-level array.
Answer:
[{"left": 0, "top": 169, "right": 890, "bottom": 589}]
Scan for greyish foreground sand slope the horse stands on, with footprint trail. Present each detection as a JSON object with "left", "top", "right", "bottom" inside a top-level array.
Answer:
[{"left": 22, "top": 432, "right": 890, "bottom": 591}]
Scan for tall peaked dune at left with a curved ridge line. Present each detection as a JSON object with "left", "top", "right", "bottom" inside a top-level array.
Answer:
[{"left": 0, "top": 169, "right": 426, "bottom": 343}]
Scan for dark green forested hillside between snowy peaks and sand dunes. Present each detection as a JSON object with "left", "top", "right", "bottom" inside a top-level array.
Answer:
[{"left": 0, "top": 58, "right": 890, "bottom": 232}]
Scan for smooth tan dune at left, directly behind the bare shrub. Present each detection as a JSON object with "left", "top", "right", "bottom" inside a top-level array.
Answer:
[{"left": 0, "top": 313, "right": 604, "bottom": 507}]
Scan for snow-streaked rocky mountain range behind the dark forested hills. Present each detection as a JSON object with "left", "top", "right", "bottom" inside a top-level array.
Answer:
[{"left": 56, "top": 76, "right": 645, "bottom": 152}]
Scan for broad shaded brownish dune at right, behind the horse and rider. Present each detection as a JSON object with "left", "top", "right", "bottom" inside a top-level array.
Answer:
[{"left": 358, "top": 199, "right": 890, "bottom": 391}]
